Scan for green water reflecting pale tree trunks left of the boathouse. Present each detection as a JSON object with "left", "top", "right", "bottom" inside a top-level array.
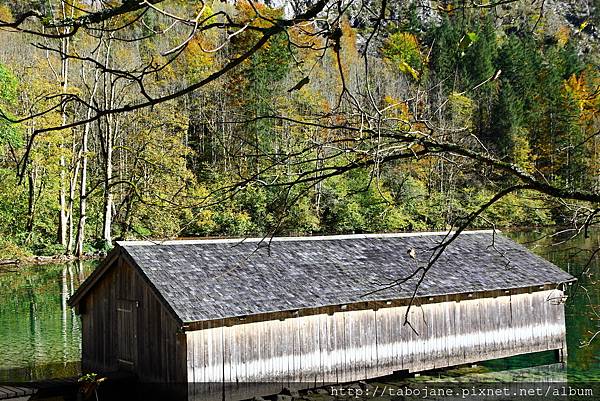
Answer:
[{"left": 0, "top": 262, "right": 95, "bottom": 380}]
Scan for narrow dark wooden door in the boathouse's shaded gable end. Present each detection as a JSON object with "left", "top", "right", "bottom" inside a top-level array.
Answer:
[{"left": 116, "top": 299, "right": 138, "bottom": 370}]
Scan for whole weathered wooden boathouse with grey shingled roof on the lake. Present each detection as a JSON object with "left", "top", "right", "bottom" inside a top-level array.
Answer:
[{"left": 69, "top": 231, "right": 574, "bottom": 385}]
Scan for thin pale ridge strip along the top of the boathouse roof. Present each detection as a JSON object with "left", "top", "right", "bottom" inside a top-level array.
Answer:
[{"left": 117, "top": 229, "right": 502, "bottom": 246}]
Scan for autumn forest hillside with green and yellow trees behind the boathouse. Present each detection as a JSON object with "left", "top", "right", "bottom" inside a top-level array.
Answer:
[{"left": 0, "top": 0, "right": 600, "bottom": 259}]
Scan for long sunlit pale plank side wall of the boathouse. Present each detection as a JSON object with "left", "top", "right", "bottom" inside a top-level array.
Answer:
[{"left": 186, "top": 290, "right": 565, "bottom": 384}]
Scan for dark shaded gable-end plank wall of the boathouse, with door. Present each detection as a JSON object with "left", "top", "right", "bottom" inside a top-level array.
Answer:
[{"left": 81, "top": 259, "right": 186, "bottom": 382}]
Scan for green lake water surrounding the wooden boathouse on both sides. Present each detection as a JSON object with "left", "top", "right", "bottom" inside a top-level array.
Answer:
[{"left": 0, "top": 230, "right": 600, "bottom": 382}]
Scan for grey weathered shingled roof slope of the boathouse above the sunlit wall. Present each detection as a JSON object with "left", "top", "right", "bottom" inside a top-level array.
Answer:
[{"left": 77, "top": 231, "right": 574, "bottom": 323}]
